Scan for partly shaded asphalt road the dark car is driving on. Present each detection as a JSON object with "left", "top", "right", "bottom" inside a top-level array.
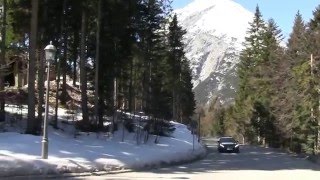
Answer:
[{"left": 7, "top": 141, "right": 320, "bottom": 180}]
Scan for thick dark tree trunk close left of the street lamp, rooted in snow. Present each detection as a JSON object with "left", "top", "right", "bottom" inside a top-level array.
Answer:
[{"left": 26, "top": 0, "right": 40, "bottom": 134}]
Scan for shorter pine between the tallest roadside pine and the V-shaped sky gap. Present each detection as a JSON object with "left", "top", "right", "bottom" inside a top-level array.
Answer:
[{"left": 259, "top": 19, "right": 284, "bottom": 146}]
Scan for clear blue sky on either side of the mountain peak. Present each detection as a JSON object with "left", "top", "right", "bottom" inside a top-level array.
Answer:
[{"left": 172, "top": 0, "right": 320, "bottom": 38}]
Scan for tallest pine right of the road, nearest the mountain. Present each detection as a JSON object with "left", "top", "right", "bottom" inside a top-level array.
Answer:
[{"left": 235, "top": 6, "right": 266, "bottom": 143}]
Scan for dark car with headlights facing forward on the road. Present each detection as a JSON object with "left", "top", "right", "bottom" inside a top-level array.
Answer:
[{"left": 218, "top": 137, "right": 240, "bottom": 153}]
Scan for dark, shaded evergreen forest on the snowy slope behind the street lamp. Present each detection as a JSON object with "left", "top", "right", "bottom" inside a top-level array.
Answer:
[{"left": 0, "top": 0, "right": 195, "bottom": 139}]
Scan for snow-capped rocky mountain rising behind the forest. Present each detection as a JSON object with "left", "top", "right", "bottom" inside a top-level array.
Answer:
[{"left": 175, "top": 0, "right": 253, "bottom": 105}]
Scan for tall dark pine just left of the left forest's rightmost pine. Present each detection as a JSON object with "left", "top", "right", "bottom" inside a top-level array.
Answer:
[{"left": 136, "top": 0, "right": 170, "bottom": 113}]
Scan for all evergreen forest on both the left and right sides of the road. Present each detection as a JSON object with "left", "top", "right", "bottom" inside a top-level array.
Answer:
[{"left": 0, "top": 0, "right": 320, "bottom": 154}]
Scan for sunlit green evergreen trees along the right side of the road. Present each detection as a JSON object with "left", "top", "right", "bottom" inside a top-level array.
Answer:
[{"left": 202, "top": 6, "right": 320, "bottom": 154}]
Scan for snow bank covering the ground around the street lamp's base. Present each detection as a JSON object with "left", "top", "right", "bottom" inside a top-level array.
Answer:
[{"left": 0, "top": 109, "right": 205, "bottom": 176}]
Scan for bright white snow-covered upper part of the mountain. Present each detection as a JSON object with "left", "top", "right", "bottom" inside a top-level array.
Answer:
[{"left": 175, "top": 0, "right": 253, "bottom": 40}]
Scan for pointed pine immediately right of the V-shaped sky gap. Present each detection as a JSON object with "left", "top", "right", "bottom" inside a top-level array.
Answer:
[{"left": 284, "top": 11, "right": 310, "bottom": 152}]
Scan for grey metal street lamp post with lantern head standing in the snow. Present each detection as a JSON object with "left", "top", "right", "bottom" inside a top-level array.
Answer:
[{"left": 41, "top": 41, "right": 57, "bottom": 159}]
